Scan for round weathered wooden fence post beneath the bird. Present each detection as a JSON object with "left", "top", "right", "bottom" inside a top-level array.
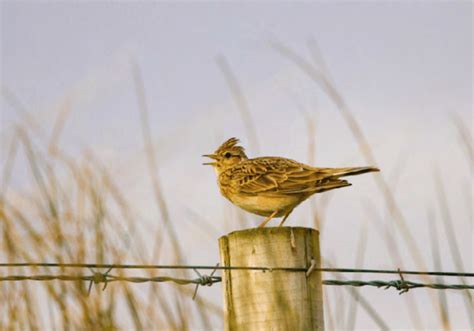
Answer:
[{"left": 219, "top": 227, "right": 324, "bottom": 331}]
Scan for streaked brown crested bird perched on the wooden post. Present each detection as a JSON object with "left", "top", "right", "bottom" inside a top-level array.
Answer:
[{"left": 202, "top": 137, "right": 380, "bottom": 227}]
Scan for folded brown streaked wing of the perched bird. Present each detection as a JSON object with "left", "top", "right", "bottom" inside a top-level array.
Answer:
[{"left": 221, "top": 157, "right": 350, "bottom": 195}]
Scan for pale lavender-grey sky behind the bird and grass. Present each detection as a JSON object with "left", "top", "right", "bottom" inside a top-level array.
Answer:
[{"left": 0, "top": 1, "right": 473, "bottom": 329}]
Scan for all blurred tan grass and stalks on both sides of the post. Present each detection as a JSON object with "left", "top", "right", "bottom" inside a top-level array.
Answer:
[{"left": 0, "top": 45, "right": 474, "bottom": 330}]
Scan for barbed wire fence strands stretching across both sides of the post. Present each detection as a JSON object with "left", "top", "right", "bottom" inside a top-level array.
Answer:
[{"left": 0, "top": 260, "right": 474, "bottom": 299}]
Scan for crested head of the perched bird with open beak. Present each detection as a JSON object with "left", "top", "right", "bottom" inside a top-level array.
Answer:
[{"left": 203, "top": 138, "right": 248, "bottom": 174}]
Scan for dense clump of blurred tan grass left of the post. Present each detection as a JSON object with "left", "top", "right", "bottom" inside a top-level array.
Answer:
[{"left": 0, "top": 76, "right": 221, "bottom": 330}]
